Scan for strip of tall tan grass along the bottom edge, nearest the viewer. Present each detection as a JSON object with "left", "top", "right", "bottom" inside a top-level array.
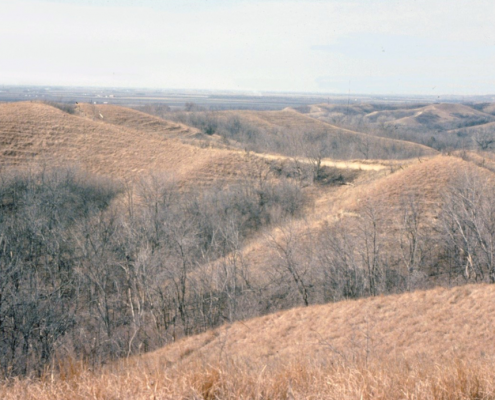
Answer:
[{"left": 0, "top": 355, "right": 495, "bottom": 400}]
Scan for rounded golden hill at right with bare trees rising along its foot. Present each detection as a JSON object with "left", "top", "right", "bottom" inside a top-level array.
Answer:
[{"left": 222, "top": 156, "right": 495, "bottom": 304}]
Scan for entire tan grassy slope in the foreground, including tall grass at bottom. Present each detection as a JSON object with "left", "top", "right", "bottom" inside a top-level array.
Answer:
[{"left": 0, "top": 285, "right": 495, "bottom": 400}]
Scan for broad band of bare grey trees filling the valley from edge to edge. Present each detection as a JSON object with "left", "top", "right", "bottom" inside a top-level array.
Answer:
[{"left": 0, "top": 164, "right": 495, "bottom": 376}]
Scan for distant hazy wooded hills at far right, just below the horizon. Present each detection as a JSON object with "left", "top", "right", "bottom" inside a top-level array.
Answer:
[{"left": 304, "top": 103, "right": 494, "bottom": 151}]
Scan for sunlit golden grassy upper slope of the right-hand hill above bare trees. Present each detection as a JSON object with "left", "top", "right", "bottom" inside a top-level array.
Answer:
[{"left": 231, "top": 154, "right": 495, "bottom": 290}]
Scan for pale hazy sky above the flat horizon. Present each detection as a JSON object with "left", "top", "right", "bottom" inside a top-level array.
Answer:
[{"left": 0, "top": 0, "right": 495, "bottom": 95}]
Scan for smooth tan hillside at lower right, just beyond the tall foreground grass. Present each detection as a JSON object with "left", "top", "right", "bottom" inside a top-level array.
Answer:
[{"left": 153, "top": 285, "right": 495, "bottom": 364}]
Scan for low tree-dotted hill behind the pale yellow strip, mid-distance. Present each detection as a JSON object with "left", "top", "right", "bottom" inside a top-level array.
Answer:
[{"left": 170, "top": 109, "right": 436, "bottom": 160}]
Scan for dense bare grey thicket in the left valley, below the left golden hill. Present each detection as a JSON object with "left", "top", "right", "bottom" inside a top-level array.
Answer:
[{"left": 0, "top": 170, "right": 305, "bottom": 375}]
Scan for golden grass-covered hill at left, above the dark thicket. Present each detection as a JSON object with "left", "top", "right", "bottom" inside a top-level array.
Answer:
[{"left": 0, "top": 103, "right": 260, "bottom": 184}]
